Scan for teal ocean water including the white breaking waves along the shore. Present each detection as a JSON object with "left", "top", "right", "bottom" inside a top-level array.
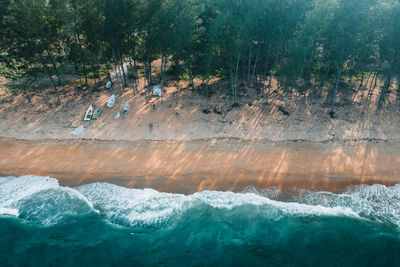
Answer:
[{"left": 0, "top": 176, "right": 400, "bottom": 266}]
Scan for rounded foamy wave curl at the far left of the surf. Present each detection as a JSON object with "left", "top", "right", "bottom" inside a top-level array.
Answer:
[{"left": 0, "top": 175, "right": 95, "bottom": 226}]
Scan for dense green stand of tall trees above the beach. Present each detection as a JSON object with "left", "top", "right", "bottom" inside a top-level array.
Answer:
[{"left": 0, "top": 0, "right": 400, "bottom": 113}]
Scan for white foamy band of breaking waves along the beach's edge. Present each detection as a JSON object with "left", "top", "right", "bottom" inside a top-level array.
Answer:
[{"left": 0, "top": 175, "right": 400, "bottom": 227}]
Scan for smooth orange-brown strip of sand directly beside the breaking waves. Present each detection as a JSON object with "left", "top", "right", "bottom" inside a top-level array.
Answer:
[{"left": 0, "top": 138, "right": 400, "bottom": 194}]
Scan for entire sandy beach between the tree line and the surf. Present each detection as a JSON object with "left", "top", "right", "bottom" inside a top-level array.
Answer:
[{"left": 0, "top": 72, "right": 400, "bottom": 193}]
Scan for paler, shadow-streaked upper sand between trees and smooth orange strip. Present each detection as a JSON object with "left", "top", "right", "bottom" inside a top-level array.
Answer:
[{"left": 0, "top": 70, "right": 400, "bottom": 141}]
